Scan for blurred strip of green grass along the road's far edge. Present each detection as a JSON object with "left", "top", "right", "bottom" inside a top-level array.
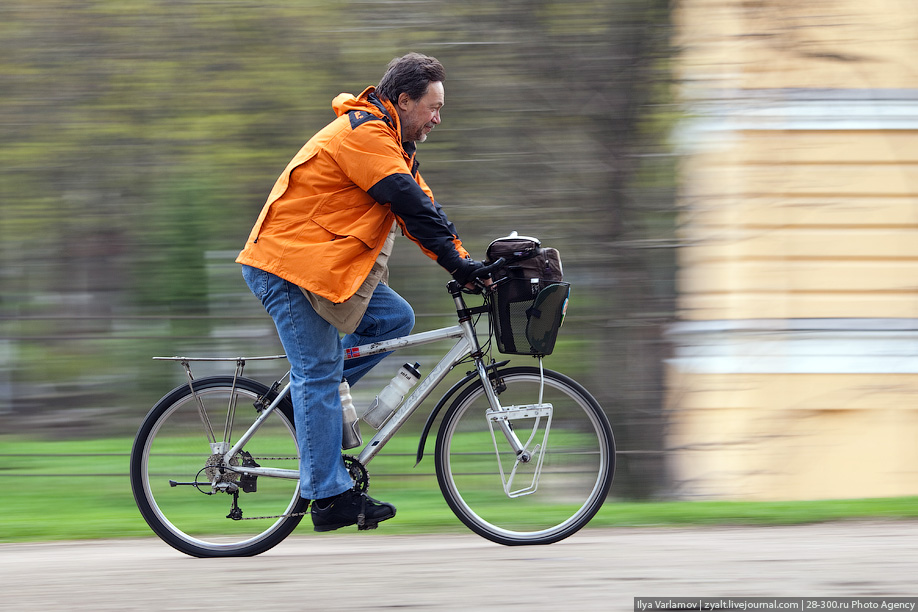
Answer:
[{"left": 0, "top": 436, "right": 918, "bottom": 542}]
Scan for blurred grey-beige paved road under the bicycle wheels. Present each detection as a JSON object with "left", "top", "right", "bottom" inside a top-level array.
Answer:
[{"left": 0, "top": 522, "right": 918, "bottom": 612}]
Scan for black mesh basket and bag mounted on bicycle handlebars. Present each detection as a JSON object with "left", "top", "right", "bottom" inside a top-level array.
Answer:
[{"left": 485, "top": 232, "right": 570, "bottom": 356}]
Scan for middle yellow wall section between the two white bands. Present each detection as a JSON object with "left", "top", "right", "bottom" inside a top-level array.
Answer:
[{"left": 679, "top": 129, "right": 918, "bottom": 320}]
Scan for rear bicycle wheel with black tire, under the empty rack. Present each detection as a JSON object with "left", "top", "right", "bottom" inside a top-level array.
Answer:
[{"left": 130, "top": 376, "right": 309, "bottom": 557}]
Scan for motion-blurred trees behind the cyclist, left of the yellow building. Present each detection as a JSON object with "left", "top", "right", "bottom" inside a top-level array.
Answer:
[{"left": 0, "top": 0, "right": 678, "bottom": 496}]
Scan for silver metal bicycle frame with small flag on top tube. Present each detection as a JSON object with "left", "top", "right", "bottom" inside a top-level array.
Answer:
[{"left": 224, "top": 306, "right": 524, "bottom": 479}]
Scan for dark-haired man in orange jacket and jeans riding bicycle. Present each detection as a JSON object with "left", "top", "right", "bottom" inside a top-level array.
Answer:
[{"left": 236, "top": 53, "right": 482, "bottom": 531}]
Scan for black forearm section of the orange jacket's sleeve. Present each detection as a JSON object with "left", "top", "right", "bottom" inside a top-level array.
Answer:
[{"left": 367, "top": 174, "right": 462, "bottom": 272}]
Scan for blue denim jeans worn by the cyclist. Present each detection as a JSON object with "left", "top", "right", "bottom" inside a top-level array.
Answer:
[{"left": 242, "top": 266, "right": 414, "bottom": 499}]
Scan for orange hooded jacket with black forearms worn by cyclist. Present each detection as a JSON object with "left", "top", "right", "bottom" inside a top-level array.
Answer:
[{"left": 236, "top": 87, "right": 468, "bottom": 303}]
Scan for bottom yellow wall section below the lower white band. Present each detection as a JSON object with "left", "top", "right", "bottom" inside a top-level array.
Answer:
[{"left": 669, "top": 370, "right": 918, "bottom": 500}]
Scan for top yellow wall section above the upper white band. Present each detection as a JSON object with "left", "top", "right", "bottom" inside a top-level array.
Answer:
[{"left": 675, "top": 0, "right": 918, "bottom": 90}]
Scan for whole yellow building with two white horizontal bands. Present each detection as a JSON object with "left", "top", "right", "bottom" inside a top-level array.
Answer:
[{"left": 668, "top": 0, "right": 918, "bottom": 499}]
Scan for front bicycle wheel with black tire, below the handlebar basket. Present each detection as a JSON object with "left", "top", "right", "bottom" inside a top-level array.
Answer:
[{"left": 435, "top": 367, "right": 615, "bottom": 546}]
